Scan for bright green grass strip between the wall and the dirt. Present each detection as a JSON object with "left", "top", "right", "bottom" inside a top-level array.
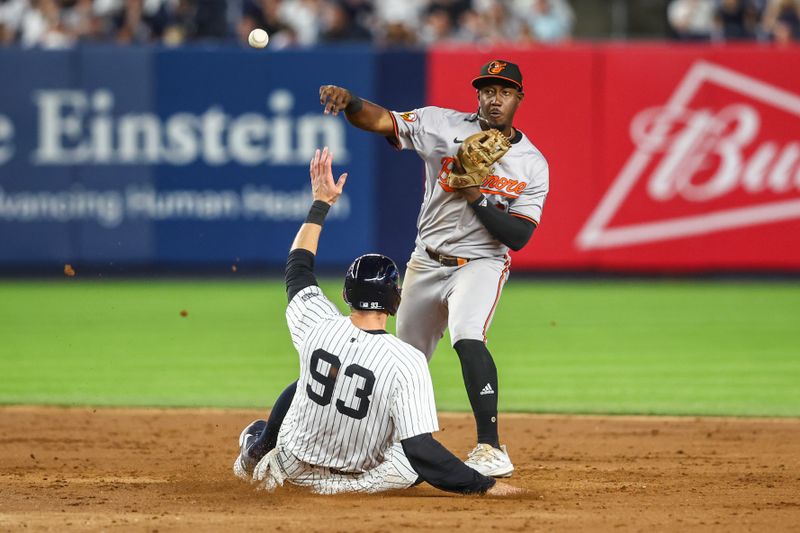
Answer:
[{"left": 0, "top": 278, "right": 800, "bottom": 416}]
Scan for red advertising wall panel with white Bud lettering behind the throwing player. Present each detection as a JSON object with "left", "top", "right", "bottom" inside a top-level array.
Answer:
[{"left": 429, "top": 45, "right": 800, "bottom": 271}]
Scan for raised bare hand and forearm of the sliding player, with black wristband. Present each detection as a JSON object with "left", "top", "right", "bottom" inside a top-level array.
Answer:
[{"left": 291, "top": 146, "right": 347, "bottom": 255}]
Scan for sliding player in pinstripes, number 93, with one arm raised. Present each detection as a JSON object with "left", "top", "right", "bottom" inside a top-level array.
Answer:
[{"left": 233, "top": 148, "right": 522, "bottom": 496}]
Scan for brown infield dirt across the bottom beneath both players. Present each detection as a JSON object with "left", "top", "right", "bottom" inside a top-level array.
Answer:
[{"left": 0, "top": 407, "right": 800, "bottom": 533}]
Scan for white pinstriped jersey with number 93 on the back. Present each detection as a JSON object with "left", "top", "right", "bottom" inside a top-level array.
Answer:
[{"left": 279, "top": 286, "right": 439, "bottom": 473}]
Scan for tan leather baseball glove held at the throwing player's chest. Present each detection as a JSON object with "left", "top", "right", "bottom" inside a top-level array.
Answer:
[{"left": 447, "top": 129, "right": 511, "bottom": 189}]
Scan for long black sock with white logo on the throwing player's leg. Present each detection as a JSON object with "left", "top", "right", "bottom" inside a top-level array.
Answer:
[{"left": 453, "top": 339, "right": 500, "bottom": 448}]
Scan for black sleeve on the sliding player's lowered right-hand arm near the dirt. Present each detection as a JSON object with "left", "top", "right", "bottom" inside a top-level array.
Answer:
[{"left": 401, "top": 433, "right": 495, "bottom": 494}]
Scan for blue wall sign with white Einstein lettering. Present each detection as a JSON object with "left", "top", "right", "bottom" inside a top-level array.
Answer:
[{"left": 0, "top": 47, "right": 379, "bottom": 265}]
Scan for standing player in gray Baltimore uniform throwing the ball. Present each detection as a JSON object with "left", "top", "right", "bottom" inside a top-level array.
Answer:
[{"left": 320, "top": 60, "right": 549, "bottom": 477}]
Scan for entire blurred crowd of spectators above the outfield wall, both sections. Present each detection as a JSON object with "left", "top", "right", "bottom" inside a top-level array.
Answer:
[{"left": 0, "top": 0, "right": 800, "bottom": 48}]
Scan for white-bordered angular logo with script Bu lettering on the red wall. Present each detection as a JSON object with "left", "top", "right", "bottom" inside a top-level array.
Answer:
[{"left": 577, "top": 61, "right": 800, "bottom": 249}]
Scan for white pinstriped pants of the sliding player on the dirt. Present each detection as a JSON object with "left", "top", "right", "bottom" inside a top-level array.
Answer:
[{"left": 253, "top": 443, "right": 419, "bottom": 494}]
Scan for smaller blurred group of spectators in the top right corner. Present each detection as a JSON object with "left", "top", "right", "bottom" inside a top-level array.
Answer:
[{"left": 667, "top": 0, "right": 800, "bottom": 44}]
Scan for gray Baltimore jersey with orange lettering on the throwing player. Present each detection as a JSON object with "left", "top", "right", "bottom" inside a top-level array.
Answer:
[{"left": 392, "top": 107, "right": 549, "bottom": 259}]
